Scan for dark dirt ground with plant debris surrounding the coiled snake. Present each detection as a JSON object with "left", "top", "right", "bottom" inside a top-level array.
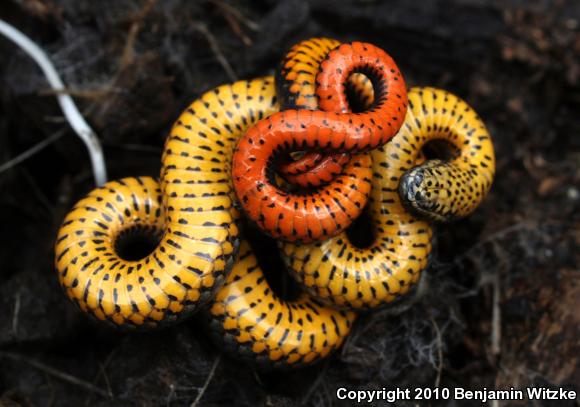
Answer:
[{"left": 0, "top": 0, "right": 580, "bottom": 407}]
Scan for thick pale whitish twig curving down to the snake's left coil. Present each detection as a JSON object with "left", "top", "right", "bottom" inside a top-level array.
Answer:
[{"left": 0, "top": 20, "right": 107, "bottom": 186}]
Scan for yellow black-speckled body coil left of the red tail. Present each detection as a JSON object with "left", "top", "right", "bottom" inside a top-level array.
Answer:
[{"left": 56, "top": 78, "right": 278, "bottom": 326}]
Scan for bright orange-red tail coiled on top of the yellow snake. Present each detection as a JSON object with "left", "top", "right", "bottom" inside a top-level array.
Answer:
[{"left": 232, "top": 42, "right": 407, "bottom": 243}]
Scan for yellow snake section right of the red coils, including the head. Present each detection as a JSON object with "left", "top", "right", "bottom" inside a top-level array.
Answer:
[{"left": 283, "top": 88, "right": 494, "bottom": 309}]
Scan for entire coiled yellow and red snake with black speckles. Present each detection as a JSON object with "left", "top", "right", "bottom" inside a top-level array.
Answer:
[{"left": 56, "top": 39, "right": 494, "bottom": 367}]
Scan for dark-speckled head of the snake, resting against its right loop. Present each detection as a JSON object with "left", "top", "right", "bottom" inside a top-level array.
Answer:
[{"left": 399, "top": 160, "right": 457, "bottom": 222}]
